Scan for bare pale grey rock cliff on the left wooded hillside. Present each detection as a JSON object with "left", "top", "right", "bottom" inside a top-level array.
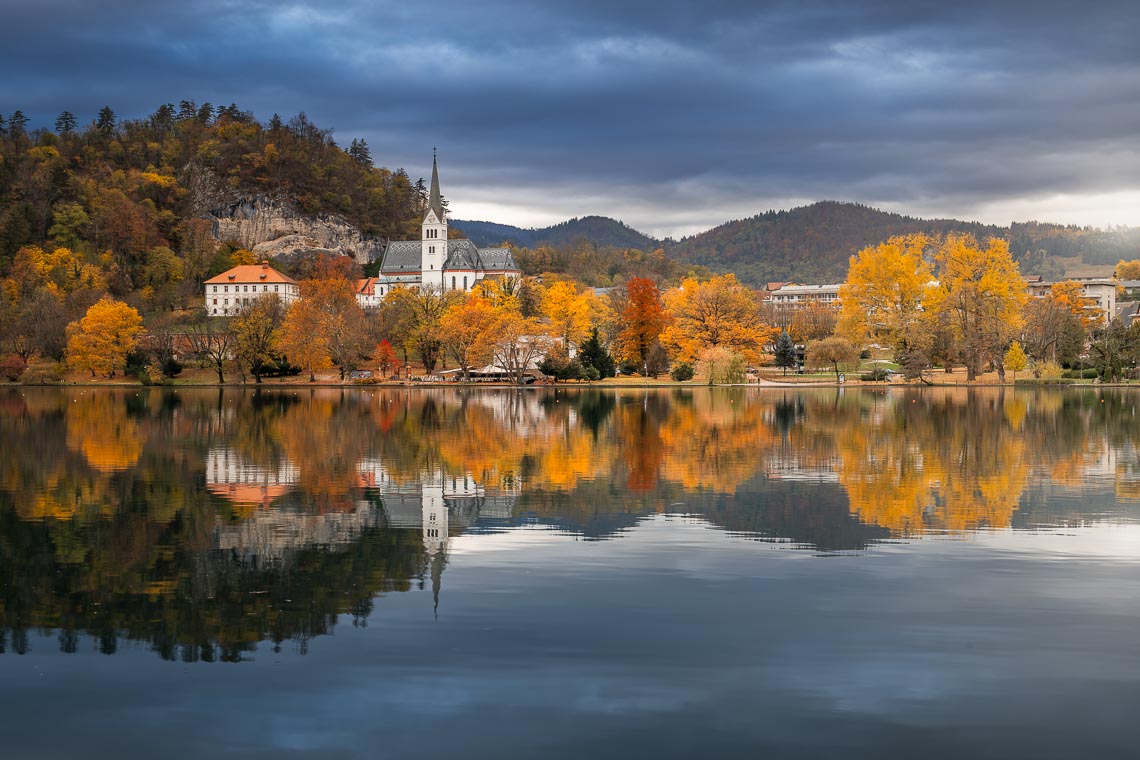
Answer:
[{"left": 184, "top": 171, "right": 384, "bottom": 264}]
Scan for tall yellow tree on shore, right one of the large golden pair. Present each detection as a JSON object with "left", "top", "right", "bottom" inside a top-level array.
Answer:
[{"left": 925, "top": 235, "right": 1028, "bottom": 381}]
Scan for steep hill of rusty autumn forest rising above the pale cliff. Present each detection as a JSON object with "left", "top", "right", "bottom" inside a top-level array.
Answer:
[{"left": 0, "top": 100, "right": 426, "bottom": 291}]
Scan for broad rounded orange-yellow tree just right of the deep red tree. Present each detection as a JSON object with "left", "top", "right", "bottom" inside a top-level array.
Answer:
[{"left": 661, "top": 275, "right": 774, "bottom": 362}]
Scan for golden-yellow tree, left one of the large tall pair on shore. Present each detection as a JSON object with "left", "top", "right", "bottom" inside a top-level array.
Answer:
[{"left": 839, "top": 235, "right": 933, "bottom": 351}]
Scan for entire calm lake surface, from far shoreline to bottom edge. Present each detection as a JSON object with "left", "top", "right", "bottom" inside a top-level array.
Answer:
[{"left": 0, "top": 389, "right": 1140, "bottom": 759}]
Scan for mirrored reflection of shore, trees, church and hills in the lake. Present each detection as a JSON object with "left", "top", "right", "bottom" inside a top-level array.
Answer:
[{"left": 0, "top": 389, "right": 1140, "bottom": 660}]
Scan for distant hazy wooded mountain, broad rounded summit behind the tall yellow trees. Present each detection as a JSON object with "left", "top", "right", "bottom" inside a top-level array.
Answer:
[{"left": 666, "top": 201, "right": 1009, "bottom": 285}]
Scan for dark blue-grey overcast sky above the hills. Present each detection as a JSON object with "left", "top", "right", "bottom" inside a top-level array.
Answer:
[{"left": 0, "top": 0, "right": 1140, "bottom": 236}]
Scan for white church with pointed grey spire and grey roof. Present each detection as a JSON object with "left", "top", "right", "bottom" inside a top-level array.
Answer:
[{"left": 375, "top": 155, "right": 522, "bottom": 297}]
